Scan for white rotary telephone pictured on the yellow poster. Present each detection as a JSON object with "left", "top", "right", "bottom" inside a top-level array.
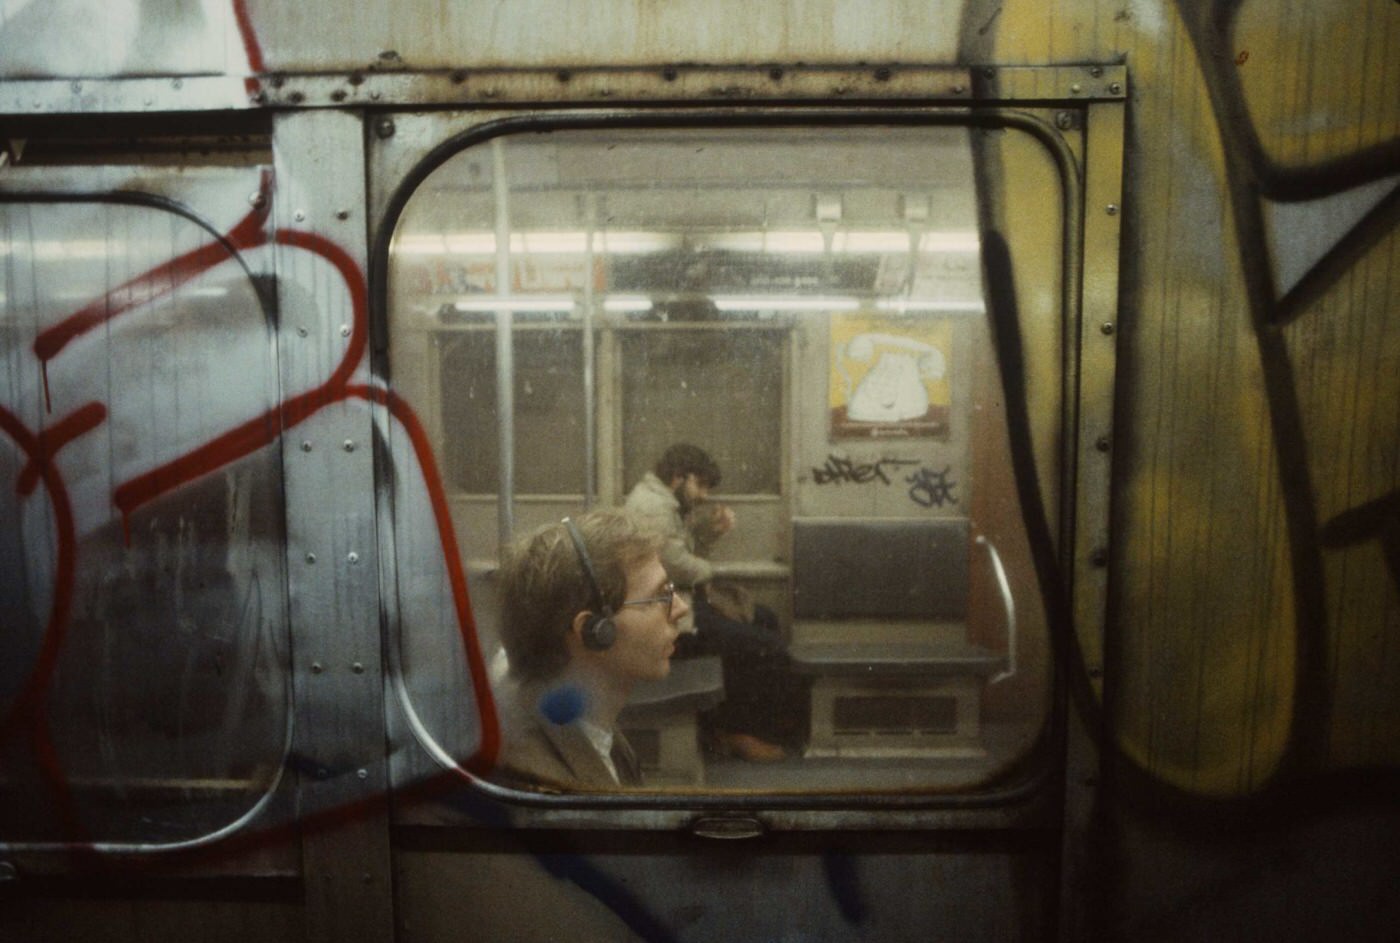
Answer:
[{"left": 836, "top": 333, "right": 948, "bottom": 423}]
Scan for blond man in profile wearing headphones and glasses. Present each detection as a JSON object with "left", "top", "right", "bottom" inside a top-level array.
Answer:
[{"left": 498, "top": 511, "right": 689, "bottom": 789}]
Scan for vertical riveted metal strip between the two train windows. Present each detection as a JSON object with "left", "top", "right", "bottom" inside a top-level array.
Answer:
[{"left": 273, "top": 112, "right": 392, "bottom": 940}]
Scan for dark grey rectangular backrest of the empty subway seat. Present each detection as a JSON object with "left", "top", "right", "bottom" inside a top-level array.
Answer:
[{"left": 792, "top": 518, "right": 967, "bottom": 620}]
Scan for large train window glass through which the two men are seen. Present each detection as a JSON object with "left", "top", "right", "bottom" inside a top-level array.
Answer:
[{"left": 389, "top": 127, "right": 1064, "bottom": 793}]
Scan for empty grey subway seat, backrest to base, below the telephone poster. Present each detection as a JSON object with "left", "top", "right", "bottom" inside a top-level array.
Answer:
[{"left": 790, "top": 518, "right": 1008, "bottom": 758}]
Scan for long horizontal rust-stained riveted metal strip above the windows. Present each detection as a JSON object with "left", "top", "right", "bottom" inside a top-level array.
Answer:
[{"left": 0, "top": 64, "right": 1126, "bottom": 115}]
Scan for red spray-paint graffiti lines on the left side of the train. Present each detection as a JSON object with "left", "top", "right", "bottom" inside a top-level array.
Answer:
[{"left": 0, "top": 172, "right": 500, "bottom": 846}]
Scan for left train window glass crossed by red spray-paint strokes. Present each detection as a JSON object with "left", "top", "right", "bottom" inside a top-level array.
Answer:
[{"left": 0, "top": 194, "right": 290, "bottom": 851}]
